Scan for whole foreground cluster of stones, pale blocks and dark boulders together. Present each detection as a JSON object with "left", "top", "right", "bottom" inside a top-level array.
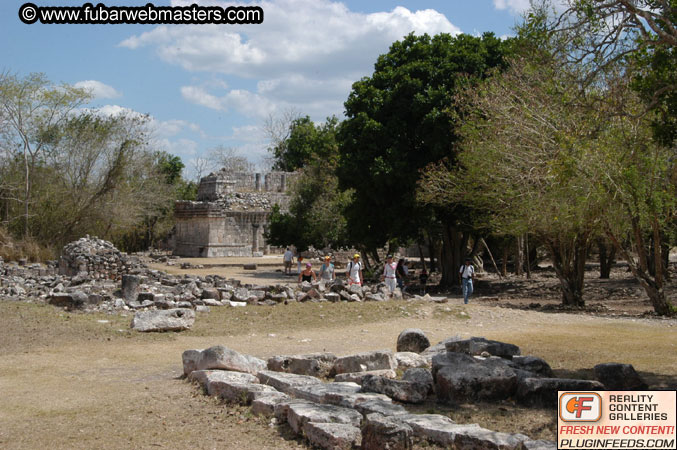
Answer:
[{"left": 182, "top": 330, "right": 646, "bottom": 450}]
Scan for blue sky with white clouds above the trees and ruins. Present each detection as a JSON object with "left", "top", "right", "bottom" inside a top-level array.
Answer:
[{"left": 0, "top": 0, "right": 529, "bottom": 177}]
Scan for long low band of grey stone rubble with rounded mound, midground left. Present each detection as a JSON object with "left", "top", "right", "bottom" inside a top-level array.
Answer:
[{"left": 0, "top": 236, "right": 446, "bottom": 332}]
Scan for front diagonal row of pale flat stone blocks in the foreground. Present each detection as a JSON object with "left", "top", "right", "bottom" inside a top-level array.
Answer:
[{"left": 188, "top": 370, "right": 555, "bottom": 450}]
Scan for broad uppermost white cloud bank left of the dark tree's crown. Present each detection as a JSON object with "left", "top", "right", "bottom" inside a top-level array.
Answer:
[{"left": 120, "top": 0, "right": 460, "bottom": 78}]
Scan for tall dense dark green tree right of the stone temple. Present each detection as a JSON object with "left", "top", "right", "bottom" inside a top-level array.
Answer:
[{"left": 338, "top": 33, "right": 512, "bottom": 284}]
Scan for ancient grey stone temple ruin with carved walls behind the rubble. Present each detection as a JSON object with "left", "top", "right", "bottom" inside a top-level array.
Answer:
[{"left": 174, "top": 169, "right": 295, "bottom": 257}]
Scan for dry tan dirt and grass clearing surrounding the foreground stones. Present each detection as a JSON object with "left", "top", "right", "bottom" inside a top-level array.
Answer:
[{"left": 0, "top": 302, "right": 677, "bottom": 449}]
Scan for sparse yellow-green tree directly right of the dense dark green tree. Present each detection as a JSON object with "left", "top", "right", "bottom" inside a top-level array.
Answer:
[{"left": 420, "top": 52, "right": 599, "bottom": 306}]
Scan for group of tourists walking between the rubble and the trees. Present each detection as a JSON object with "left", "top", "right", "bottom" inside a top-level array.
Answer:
[{"left": 282, "top": 247, "right": 475, "bottom": 304}]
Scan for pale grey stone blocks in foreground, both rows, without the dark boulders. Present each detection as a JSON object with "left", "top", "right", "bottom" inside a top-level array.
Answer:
[{"left": 183, "top": 346, "right": 555, "bottom": 449}]
